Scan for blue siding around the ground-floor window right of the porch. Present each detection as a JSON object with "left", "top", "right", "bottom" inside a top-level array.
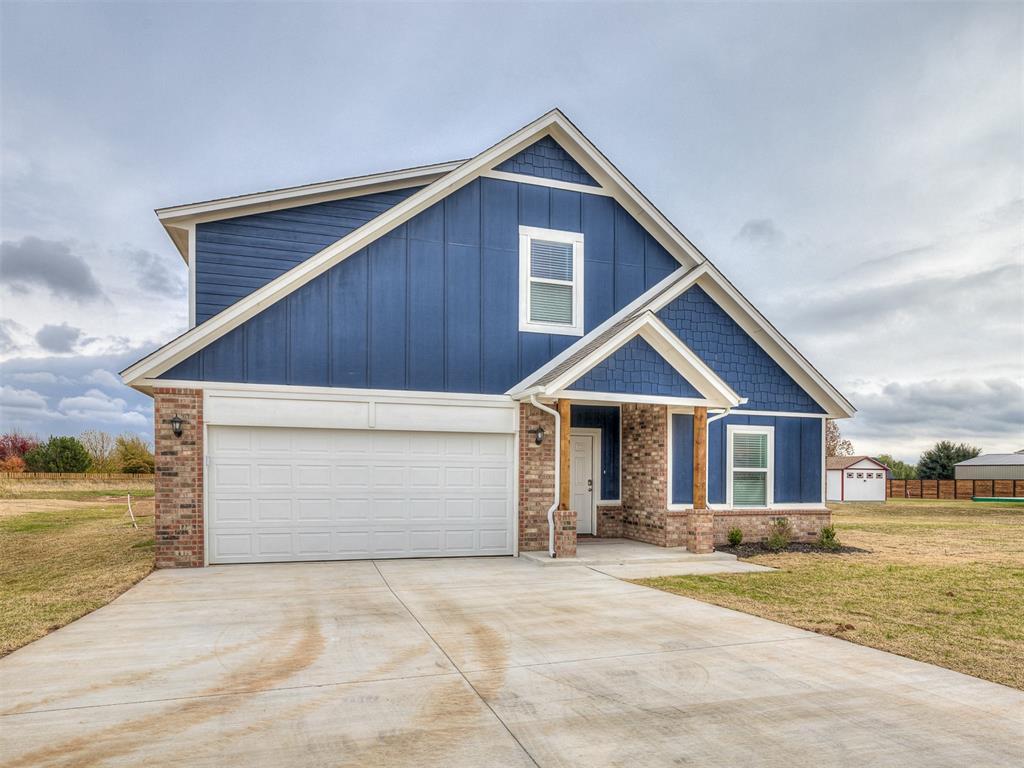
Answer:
[{"left": 672, "top": 411, "right": 824, "bottom": 505}]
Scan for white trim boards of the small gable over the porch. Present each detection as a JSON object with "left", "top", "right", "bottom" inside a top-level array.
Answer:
[{"left": 528, "top": 310, "right": 745, "bottom": 408}]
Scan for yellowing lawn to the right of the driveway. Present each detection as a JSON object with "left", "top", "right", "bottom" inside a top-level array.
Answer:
[{"left": 639, "top": 500, "right": 1024, "bottom": 688}]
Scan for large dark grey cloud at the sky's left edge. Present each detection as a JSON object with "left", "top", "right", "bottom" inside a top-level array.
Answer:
[{"left": 0, "top": 237, "right": 104, "bottom": 302}]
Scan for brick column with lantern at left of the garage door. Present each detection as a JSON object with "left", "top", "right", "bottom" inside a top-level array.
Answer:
[{"left": 153, "top": 388, "right": 204, "bottom": 568}]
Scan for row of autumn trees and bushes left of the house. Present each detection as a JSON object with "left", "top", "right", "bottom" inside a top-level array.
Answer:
[{"left": 0, "top": 430, "right": 154, "bottom": 474}]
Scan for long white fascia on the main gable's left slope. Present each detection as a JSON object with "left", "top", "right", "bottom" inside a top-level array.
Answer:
[{"left": 121, "top": 110, "right": 598, "bottom": 386}]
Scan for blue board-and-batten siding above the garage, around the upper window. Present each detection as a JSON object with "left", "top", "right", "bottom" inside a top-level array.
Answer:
[{"left": 162, "top": 178, "right": 679, "bottom": 393}]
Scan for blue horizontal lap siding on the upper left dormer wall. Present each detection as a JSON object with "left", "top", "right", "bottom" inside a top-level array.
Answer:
[{"left": 196, "top": 186, "right": 422, "bottom": 324}]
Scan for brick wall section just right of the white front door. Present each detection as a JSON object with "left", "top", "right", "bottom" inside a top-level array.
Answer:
[{"left": 621, "top": 402, "right": 682, "bottom": 547}]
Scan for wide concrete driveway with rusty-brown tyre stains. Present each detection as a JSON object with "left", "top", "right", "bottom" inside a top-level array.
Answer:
[{"left": 0, "top": 558, "right": 1024, "bottom": 768}]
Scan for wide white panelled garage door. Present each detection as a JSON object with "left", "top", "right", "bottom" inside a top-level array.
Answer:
[{"left": 207, "top": 427, "right": 514, "bottom": 563}]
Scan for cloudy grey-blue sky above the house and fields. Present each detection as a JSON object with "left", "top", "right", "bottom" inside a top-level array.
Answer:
[{"left": 0, "top": 2, "right": 1024, "bottom": 460}]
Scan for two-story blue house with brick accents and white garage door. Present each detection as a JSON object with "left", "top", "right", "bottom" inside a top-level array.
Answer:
[{"left": 123, "top": 110, "right": 854, "bottom": 566}]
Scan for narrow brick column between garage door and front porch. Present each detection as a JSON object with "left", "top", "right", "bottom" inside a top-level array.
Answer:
[{"left": 519, "top": 402, "right": 555, "bottom": 552}]
